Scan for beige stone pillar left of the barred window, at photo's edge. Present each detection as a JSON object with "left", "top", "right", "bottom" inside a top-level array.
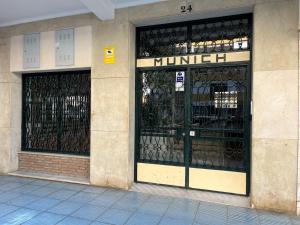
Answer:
[{"left": 0, "top": 37, "right": 22, "bottom": 173}]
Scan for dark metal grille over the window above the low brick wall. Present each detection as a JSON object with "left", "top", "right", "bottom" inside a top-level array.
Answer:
[{"left": 22, "top": 71, "right": 91, "bottom": 155}]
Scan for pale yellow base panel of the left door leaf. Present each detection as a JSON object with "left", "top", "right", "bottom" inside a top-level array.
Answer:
[{"left": 137, "top": 163, "right": 185, "bottom": 187}]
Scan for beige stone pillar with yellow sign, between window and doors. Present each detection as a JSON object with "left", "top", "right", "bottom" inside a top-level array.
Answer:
[{"left": 90, "top": 14, "right": 134, "bottom": 189}]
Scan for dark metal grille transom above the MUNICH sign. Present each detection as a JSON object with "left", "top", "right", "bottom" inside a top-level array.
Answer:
[{"left": 137, "top": 15, "right": 252, "bottom": 58}]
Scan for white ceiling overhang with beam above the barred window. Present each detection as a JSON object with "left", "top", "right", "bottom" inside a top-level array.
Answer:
[{"left": 0, "top": 0, "right": 166, "bottom": 27}]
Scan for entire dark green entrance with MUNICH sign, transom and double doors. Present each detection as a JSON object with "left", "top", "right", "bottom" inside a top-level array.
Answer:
[{"left": 135, "top": 14, "right": 252, "bottom": 195}]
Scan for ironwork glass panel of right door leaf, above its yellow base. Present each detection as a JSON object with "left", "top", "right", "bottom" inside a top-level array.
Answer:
[{"left": 190, "top": 66, "right": 248, "bottom": 170}]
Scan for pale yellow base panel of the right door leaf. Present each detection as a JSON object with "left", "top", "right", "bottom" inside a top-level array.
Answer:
[{"left": 189, "top": 168, "right": 246, "bottom": 195}]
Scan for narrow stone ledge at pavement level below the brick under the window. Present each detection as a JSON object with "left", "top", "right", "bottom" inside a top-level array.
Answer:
[{"left": 8, "top": 170, "right": 90, "bottom": 185}]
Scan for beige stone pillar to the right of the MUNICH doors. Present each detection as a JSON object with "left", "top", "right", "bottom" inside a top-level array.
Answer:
[{"left": 251, "top": 0, "right": 298, "bottom": 213}]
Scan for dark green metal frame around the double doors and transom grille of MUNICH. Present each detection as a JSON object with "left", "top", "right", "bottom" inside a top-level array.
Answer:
[{"left": 134, "top": 13, "right": 254, "bottom": 196}]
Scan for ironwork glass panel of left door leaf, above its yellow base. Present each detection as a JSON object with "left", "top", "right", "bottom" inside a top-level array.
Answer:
[{"left": 138, "top": 70, "right": 184, "bottom": 164}]
